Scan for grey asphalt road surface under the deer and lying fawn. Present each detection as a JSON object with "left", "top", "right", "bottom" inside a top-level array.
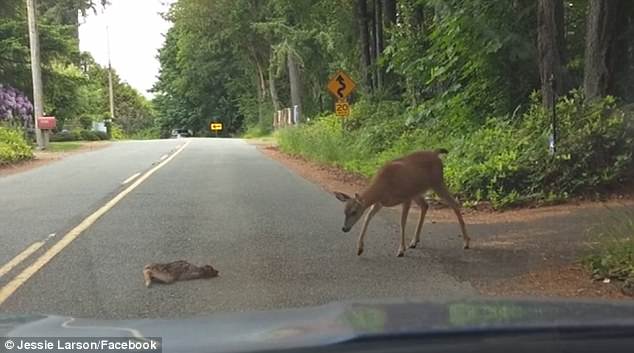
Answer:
[{"left": 0, "top": 139, "right": 475, "bottom": 319}]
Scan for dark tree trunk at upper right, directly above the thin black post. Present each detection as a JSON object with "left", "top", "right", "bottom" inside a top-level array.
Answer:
[{"left": 537, "top": 0, "right": 567, "bottom": 110}]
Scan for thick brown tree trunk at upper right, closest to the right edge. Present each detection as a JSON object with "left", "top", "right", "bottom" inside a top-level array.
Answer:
[{"left": 583, "top": 0, "right": 621, "bottom": 100}]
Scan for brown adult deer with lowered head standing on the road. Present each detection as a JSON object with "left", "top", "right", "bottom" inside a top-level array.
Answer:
[{"left": 333, "top": 148, "right": 471, "bottom": 257}]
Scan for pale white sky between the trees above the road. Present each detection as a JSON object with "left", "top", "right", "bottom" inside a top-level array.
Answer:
[{"left": 79, "top": 0, "right": 174, "bottom": 97}]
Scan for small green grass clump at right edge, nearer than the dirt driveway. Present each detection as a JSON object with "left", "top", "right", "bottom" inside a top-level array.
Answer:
[{"left": 583, "top": 208, "right": 634, "bottom": 291}]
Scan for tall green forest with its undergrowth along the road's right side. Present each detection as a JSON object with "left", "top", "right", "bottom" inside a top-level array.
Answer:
[{"left": 155, "top": 0, "right": 634, "bottom": 207}]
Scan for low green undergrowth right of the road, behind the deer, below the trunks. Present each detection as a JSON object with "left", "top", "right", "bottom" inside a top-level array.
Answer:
[{"left": 279, "top": 91, "right": 634, "bottom": 209}]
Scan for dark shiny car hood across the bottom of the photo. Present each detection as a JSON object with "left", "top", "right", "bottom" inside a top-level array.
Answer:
[{"left": 0, "top": 300, "right": 634, "bottom": 352}]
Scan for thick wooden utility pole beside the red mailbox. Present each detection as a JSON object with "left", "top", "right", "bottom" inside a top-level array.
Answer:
[{"left": 26, "top": 0, "right": 48, "bottom": 149}]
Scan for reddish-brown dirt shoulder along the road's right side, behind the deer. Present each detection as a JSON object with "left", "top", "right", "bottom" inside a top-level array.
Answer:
[{"left": 250, "top": 141, "right": 634, "bottom": 299}]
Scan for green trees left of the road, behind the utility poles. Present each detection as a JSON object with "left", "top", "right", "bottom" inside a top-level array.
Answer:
[{"left": 0, "top": 0, "right": 155, "bottom": 135}]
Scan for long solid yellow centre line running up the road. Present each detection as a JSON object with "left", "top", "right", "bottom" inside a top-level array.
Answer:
[{"left": 0, "top": 141, "right": 189, "bottom": 305}]
